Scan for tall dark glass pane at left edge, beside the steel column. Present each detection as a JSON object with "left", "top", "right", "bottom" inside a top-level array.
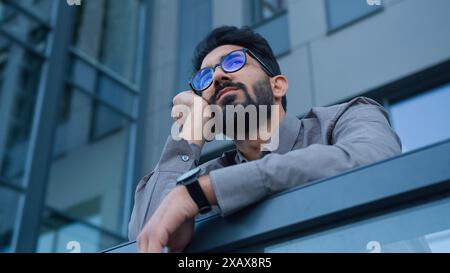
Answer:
[{"left": 0, "top": 18, "right": 44, "bottom": 183}]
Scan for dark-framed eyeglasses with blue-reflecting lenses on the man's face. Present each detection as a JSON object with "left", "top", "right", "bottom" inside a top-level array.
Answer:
[{"left": 189, "top": 48, "right": 274, "bottom": 95}]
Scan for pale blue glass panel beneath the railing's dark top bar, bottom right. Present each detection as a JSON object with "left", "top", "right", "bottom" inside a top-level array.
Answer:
[{"left": 264, "top": 196, "right": 450, "bottom": 253}]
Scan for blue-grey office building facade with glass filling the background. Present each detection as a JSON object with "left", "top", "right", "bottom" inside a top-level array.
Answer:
[{"left": 0, "top": 0, "right": 450, "bottom": 252}]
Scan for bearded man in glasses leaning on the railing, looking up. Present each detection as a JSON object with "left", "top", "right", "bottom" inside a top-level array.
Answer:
[{"left": 129, "top": 27, "right": 401, "bottom": 252}]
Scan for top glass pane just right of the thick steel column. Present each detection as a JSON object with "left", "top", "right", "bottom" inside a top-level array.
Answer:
[{"left": 74, "top": 0, "right": 140, "bottom": 82}]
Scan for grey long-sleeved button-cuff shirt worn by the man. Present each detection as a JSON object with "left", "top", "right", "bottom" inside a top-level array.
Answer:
[{"left": 129, "top": 97, "right": 401, "bottom": 240}]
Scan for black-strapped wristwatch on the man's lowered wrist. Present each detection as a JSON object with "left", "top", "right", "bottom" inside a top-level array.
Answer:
[{"left": 177, "top": 167, "right": 211, "bottom": 214}]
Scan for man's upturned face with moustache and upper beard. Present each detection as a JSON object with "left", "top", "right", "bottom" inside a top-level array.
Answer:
[{"left": 201, "top": 45, "right": 274, "bottom": 109}]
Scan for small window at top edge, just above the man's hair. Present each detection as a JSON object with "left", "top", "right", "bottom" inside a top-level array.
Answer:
[{"left": 251, "top": 0, "right": 286, "bottom": 25}]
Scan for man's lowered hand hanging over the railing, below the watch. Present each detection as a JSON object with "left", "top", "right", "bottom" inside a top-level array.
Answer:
[{"left": 137, "top": 175, "right": 217, "bottom": 252}]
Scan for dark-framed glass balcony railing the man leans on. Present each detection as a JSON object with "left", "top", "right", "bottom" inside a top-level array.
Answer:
[{"left": 106, "top": 140, "right": 450, "bottom": 252}]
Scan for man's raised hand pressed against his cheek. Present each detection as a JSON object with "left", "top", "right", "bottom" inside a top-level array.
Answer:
[{"left": 172, "top": 91, "right": 214, "bottom": 148}]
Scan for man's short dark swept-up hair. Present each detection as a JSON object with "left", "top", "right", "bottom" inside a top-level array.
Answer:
[{"left": 193, "top": 26, "right": 287, "bottom": 111}]
